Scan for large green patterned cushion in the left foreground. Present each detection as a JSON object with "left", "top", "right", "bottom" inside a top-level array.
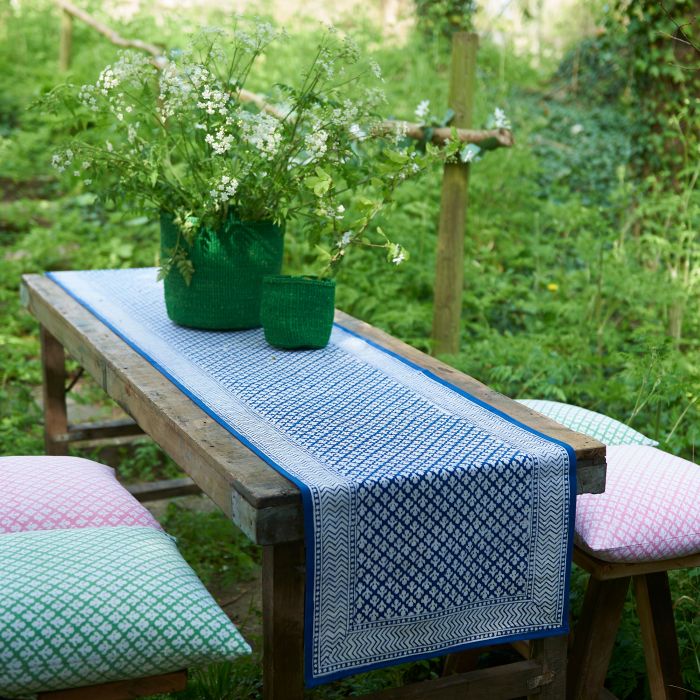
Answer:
[{"left": 0, "top": 527, "right": 250, "bottom": 697}]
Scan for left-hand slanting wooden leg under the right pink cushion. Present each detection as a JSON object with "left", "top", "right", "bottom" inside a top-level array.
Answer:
[{"left": 566, "top": 576, "right": 630, "bottom": 700}]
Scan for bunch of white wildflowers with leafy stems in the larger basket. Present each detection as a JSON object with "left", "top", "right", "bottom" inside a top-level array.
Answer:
[{"left": 41, "top": 18, "right": 426, "bottom": 284}]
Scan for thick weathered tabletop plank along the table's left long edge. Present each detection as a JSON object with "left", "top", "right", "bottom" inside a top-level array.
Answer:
[{"left": 22, "top": 275, "right": 303, "bottom": 544}]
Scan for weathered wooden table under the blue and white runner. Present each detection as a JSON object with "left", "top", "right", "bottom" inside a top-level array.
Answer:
[{"left": 21, "top": 275, "right": 605, "bottom": 700}]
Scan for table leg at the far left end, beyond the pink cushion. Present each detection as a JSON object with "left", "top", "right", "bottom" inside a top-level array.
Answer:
[{"left": 40, "top": 326, "right": 68, "bottom": 455}]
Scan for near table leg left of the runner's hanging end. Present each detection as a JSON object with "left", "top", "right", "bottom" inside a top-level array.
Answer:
[{"left": 263, "top": 541, "right": 305, "bottom": 700}]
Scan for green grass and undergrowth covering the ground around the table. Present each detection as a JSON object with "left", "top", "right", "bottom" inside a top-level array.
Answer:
[{"left": 0, "top": 2, "right": 700, "bottom": 699}]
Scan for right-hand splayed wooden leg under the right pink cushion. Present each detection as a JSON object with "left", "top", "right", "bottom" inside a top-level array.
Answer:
[{"left": 633, "top": 571, "right": 685, "bottom": 700}]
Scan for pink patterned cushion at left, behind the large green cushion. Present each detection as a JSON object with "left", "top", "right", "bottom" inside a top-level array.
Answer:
[{"left": 0, "top": 457, "right": 160, "bottom": 534}]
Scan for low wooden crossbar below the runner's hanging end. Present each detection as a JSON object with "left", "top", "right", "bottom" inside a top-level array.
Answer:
[{"left": 362, "top": 661, "right": 548, "bottom": 700}]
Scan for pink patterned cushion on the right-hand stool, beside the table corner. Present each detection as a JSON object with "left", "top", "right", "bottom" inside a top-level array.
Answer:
[{"left": 576, "top": 445, "right": 700, "bottom": 562}]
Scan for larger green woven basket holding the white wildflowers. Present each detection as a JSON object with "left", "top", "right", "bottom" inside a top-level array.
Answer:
[{"left": 160, "top": 214, "right": 284, "bottom": 330}]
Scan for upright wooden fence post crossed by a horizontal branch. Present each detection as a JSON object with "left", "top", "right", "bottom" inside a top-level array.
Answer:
[{"left": 433, "top": 32, "right": 479, "bottom": 355}]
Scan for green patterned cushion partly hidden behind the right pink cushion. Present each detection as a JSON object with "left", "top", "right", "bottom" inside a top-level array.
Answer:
[{"left": 518, "top": 399, "right": 659, "bottom": 446}]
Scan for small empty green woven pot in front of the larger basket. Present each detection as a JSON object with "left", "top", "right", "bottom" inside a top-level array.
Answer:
[{"left": 260, "top": 275, "right": 335, "bottom": 350}]
